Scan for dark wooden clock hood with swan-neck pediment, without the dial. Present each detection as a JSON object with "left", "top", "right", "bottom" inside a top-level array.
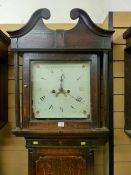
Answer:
[{"left": 8, "top": 9, "right": 113, "bottom": 136}]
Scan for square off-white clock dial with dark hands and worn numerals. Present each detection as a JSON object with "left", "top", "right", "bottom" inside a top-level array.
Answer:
[{"left": 31, "top": 61, "right": 91, "bottom": 120}]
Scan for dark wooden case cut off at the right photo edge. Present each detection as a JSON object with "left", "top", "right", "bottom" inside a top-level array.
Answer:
[{"left": 123, "top": 27, "right": 131, "bottom": 136}]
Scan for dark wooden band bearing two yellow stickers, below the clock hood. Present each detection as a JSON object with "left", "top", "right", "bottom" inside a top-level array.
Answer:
[{"left": 26, "top": 137, "right": 104, "bottom": 149}]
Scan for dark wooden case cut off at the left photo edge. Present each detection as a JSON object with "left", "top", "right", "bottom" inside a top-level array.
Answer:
[{"left": 0, "top": 31, "right": 10, "bottom": 128}]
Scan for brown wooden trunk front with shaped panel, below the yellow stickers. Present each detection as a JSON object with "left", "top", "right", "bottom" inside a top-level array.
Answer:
[{"left": 29, "top": 147, "right": 93, "bottom": 175}]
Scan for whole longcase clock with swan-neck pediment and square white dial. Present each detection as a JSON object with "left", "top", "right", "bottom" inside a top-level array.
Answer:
[{"left": 8, "top": 9, "right": 114, "bottom": 175}]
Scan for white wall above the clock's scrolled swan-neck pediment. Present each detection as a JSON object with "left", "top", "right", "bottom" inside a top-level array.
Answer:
[{"left": 0, "top": 0, "right": 131, "bottom": 24}]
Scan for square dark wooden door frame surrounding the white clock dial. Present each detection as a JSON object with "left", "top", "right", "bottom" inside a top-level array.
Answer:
[{"left": 22, "top": 53, "right": 100, "bottom": 129}]
